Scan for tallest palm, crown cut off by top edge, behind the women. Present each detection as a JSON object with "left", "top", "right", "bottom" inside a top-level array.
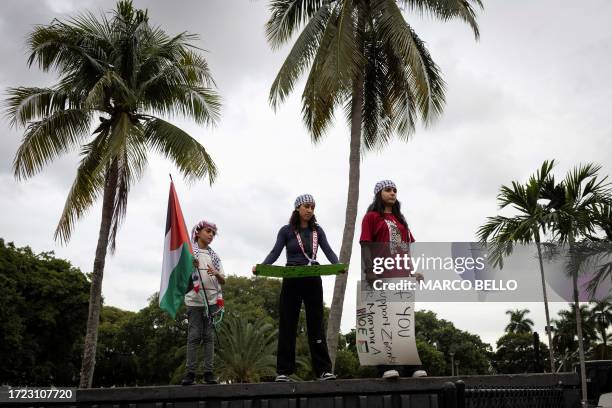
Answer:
[{"left": 266, "top": 0, "right": 482, "bottom": 362}]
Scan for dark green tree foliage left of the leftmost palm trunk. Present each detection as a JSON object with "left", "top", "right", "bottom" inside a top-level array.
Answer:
[{"left": 0, "top": 239, "right": 89, "bottom": 386}]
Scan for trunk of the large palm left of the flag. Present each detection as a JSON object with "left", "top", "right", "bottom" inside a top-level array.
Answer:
[{"left": 79, "top": 161, "right": 118, "bottom": 388}]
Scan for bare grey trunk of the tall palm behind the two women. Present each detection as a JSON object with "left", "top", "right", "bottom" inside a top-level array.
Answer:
[{"left": 327, "top": 71, "right": 363, "bottom": 367}]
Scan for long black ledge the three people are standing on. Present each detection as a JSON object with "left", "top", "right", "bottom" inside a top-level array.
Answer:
[{"left": 5, "top": 373, "right": 580, "bottom": 408}]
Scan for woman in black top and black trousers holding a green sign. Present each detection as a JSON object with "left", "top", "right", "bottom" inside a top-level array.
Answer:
[{"left": 253, "top": 194, "right": 338, "bottom": 382}]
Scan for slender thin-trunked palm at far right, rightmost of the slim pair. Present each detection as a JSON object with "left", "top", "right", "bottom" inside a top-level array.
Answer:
[{"left": 542, "top": 163, "right": 610, "bottom": 403}]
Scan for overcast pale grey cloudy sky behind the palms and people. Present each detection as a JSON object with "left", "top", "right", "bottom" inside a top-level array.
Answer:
[{"left": 0, "top": 0, "right": 612, "bottom": 345}]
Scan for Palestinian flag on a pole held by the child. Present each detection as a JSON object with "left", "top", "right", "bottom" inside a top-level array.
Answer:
[{"left": 159, "top": 182, "right": 193, "bottom": 318}]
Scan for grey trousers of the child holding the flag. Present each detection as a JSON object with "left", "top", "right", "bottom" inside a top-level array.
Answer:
[{"left": 187, "top": 305, "right": 217, "bottom": 373}]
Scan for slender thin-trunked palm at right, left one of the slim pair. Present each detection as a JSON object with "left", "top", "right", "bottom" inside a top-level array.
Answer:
[{"left": 477, "top": 160, "right": 555, "bottom": 373}]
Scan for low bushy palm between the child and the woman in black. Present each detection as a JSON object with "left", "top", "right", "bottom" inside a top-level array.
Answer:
[{"left": 217, "top": 317, "right": 278, "bottom": 382}]
